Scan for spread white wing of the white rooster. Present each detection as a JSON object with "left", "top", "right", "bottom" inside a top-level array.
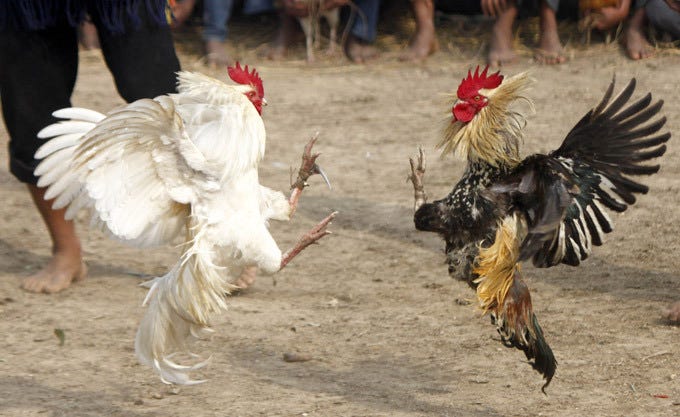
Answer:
[{"left": 35, "top": 96, "right": 220, "bottom": 246}]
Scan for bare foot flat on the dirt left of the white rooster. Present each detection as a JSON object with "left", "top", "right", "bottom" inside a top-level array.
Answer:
[{"left": 21, "top": 253, "right": 87, "bottom": 294}]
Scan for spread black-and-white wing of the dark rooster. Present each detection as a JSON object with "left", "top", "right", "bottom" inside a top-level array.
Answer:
[{"left": 488, "top": 79, "right": 670, "bottom": 267}]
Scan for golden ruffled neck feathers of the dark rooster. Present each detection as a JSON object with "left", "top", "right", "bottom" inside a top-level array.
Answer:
[{"left": 437, "top": 72, "right": 533, "bottom": 167}]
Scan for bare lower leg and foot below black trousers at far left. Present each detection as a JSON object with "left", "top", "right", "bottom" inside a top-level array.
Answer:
[{"left": 21, "top": 185, "right": 87, "bottom": 293}]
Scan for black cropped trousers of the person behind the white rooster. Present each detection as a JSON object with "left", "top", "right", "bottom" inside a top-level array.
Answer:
[{"left": 0, "top": 3, "right": 180, "bottom": 184}]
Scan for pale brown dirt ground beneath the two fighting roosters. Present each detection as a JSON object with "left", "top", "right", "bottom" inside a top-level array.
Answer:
[{"left": 0, "top": 12, "right": 680, "bottom": 417}]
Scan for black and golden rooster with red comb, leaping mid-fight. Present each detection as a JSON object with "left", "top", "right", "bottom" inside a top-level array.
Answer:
[{"left": 410, "top": 67, "right": 670, "bottom": 390}]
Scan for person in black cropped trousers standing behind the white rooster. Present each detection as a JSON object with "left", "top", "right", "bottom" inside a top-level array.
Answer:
[{"left": 0, "top": 0, "right": 180, "bottom": 293}]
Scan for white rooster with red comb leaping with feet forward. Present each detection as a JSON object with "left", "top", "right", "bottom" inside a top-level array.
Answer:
[{"left": 35, "top": 63, "right": 335, "bottom": 384}]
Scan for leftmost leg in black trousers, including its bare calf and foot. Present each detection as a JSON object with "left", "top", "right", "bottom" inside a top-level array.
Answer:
[{"left": 0, "top": 26, "right": 87, "bottom": 293}]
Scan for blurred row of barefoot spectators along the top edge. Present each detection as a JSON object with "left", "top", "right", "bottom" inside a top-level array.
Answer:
[{"left": 82, "top": 0, "right": 680, "bottom": 66}]
